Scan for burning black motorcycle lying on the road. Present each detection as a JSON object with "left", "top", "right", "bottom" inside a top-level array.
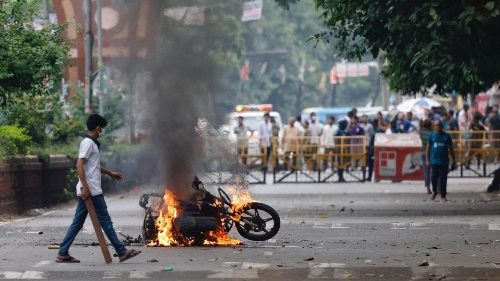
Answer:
[{"left": 139, "top": 177, "right": 280, "bottom": 246}]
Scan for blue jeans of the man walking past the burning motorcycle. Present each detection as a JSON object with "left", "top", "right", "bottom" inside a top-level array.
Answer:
[{"left": 59, "top": 194, "right": 126, "bottom": 256}]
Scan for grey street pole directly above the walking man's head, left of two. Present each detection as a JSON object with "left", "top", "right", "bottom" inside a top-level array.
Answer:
[{"left": 85, "top": 0, "right": 94, "bottom": 113}]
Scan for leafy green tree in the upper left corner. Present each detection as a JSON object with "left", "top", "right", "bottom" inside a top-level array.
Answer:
[{"left": 0, "top": 0, "right": 68, "bottom": 106}]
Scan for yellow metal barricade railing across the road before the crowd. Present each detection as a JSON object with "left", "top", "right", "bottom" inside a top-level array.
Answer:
[{"left": 224, "top": 131, "right": 500, "bottom": 183}]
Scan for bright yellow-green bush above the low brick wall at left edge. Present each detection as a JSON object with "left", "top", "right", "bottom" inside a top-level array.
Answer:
[{"left": 0, "top": 125, "right": 31, "bottom": 157}]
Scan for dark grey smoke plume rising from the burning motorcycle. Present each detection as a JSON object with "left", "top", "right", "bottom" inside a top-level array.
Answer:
[{"left": 110, "top": 0, "right": 239, "bottom": 199}]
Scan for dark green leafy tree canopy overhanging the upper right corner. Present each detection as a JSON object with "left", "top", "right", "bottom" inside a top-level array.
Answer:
[{"left": 276, "top": 0, "right": 500, "bottom": 94}]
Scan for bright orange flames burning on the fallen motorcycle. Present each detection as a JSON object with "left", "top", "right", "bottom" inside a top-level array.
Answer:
[{"left": 148, "top": 186, "right": 253, "bottom": 246}]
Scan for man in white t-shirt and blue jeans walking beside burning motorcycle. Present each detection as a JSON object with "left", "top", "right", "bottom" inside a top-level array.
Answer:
[{"left": 56, "top": 114, "right": 141, "bottom": 263}]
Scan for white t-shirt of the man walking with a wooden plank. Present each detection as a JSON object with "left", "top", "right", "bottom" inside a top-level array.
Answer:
[{"left": 76, "top": 137, "right": 102, "bottom": 196}]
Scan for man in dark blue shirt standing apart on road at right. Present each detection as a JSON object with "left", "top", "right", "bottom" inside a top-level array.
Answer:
[{"left": 427, "top": 120, "right": 456, "bottom": 203}]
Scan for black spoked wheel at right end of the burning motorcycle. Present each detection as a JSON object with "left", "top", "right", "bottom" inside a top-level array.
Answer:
[{"left": 235, "top": 202, "right": 280, "bottom": 241}]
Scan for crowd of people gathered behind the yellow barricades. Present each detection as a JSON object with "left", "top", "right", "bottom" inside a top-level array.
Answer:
[{"left": 235, "top": 104, "right": 500, "bottom": 194}]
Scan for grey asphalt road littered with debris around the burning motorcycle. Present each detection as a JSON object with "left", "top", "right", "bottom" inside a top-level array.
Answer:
[{"left": 0, "top": 179, "right": 500, "bottom": 280}]
